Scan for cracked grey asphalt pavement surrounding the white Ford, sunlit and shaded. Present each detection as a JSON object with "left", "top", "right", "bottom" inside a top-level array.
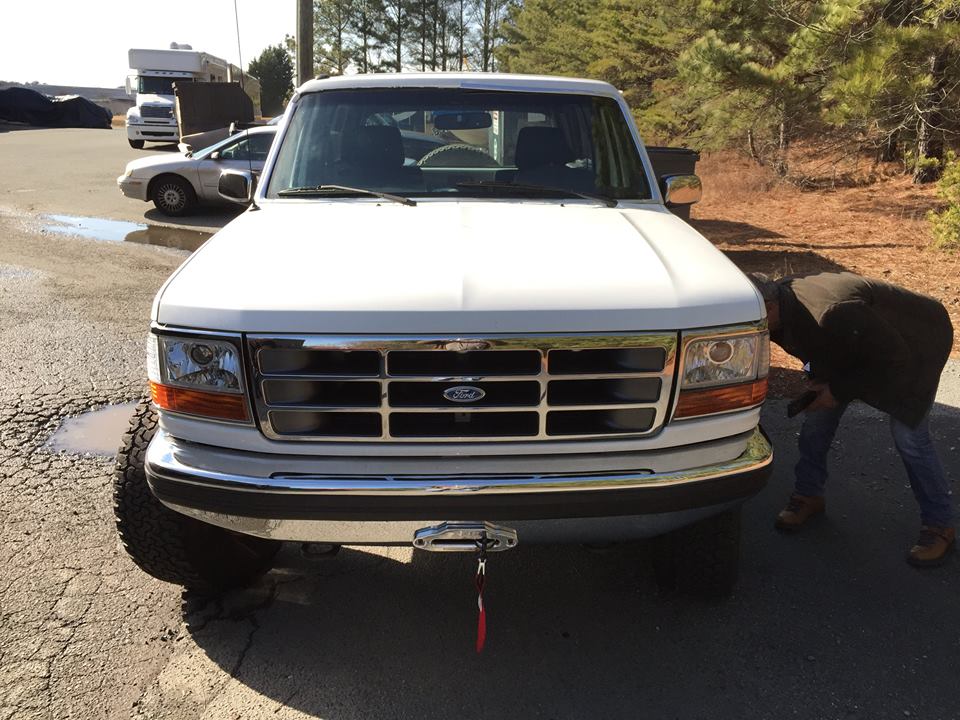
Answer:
[{"left": 0, "top": 131, "right": 960, "bottom": 720}]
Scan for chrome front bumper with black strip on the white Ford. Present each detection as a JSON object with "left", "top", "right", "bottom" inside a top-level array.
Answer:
[{"left": 145, "top": 428, "right": 773, "bottom": 545}]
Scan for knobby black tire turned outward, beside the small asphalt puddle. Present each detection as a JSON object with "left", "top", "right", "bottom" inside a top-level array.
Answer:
[{"left": 113, "top": 402, "right": 280, "bottom": 595}]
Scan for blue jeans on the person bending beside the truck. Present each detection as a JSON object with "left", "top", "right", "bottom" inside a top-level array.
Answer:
[{"left": 795, "top": 405, "right": 954, "bottom": 527}]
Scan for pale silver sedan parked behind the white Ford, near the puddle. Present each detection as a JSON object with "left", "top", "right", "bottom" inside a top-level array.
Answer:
[{"left": 117, "top": 126, "right": 277, "bottom": 216}]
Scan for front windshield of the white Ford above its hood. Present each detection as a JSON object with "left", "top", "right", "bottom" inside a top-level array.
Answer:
[{"left": 267, "top": 88, "right": 650, "bottom": 200}]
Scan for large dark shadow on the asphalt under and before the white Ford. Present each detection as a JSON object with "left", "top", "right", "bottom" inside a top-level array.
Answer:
[{"left": 185, "top": 400, "right": 960, "bottom": 719}]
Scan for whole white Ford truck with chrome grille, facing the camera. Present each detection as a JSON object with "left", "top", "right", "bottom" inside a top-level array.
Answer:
[{"left": 115, "top": 74, "right": 772, "bottom": 595}]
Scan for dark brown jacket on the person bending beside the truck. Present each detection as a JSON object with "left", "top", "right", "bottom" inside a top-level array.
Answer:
[{"left": 771, "top": 272, "right": 953, "bottom": 427}]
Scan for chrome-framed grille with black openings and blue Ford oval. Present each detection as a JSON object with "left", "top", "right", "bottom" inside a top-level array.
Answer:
[{"left": 247, "top": 333, "right": 677, "bottom": 442}]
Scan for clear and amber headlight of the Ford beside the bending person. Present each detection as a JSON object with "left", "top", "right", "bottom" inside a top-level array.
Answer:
[{"left": 674, "top": 331, "right": 770, "bottom": 418}]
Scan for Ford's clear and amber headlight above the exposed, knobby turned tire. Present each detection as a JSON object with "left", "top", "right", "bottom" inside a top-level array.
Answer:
[{"left": 147, "top": 334, "right": 249, "bottom": 421}]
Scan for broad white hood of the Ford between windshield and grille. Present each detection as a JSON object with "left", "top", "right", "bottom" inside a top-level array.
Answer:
[{"left": 154, "top": 199, "right": 762, "bottom": 335}]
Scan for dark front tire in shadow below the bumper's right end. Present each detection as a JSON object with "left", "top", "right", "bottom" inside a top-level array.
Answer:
[{"left": 653, "top": 508, "right": 740, "bottom": 600}]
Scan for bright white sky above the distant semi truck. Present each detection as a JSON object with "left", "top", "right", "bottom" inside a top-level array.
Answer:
[{"left": 0, "top": 0, "right": 297, "bottom": 87}]
